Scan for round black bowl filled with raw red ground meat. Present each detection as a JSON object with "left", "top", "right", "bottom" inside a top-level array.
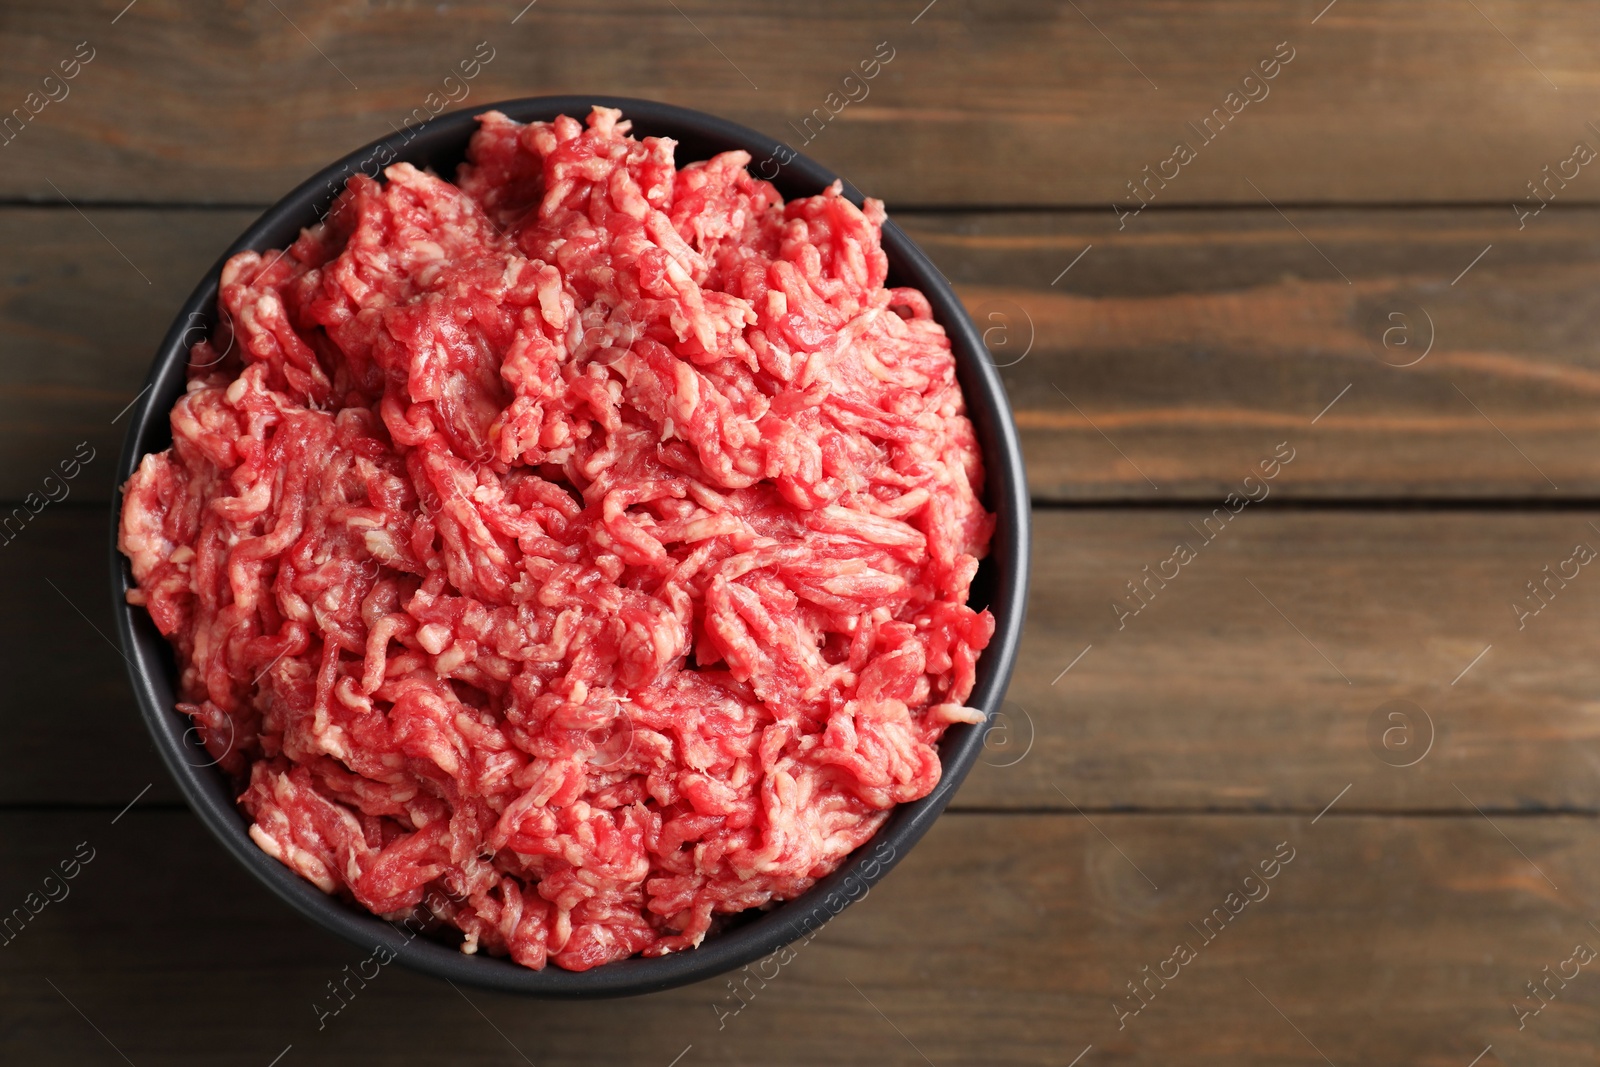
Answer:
[{"left": 112, "top": 96, "right": 1029, "bottom": 997}]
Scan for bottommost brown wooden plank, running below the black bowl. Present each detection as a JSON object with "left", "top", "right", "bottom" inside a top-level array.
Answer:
[{"left": 0, "top": 808, "right": 1600, "bottom": 1067}]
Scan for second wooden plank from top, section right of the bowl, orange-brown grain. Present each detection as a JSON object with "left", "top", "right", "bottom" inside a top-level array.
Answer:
[{"left": 910, "top": 208, "right": 1600, "bottom": 501}]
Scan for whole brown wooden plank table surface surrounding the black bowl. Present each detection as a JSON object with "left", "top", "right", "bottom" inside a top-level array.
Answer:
[{"left": 0, "top": 0, "right": 1600, "bottom": 1067}]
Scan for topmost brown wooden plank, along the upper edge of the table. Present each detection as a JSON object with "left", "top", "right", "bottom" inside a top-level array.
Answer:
[{"left": 9, "top": 0, "right": 1600, "bottom": 213}]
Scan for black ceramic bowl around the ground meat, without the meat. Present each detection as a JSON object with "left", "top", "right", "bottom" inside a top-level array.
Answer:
[{"left": 110, "top": 96, "right": 1029, "bottom": 997}]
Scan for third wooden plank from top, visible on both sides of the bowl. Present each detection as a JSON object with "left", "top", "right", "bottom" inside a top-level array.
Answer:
[{"left": 12, "top": 505, "right": 1600, "bottom": 813}]
